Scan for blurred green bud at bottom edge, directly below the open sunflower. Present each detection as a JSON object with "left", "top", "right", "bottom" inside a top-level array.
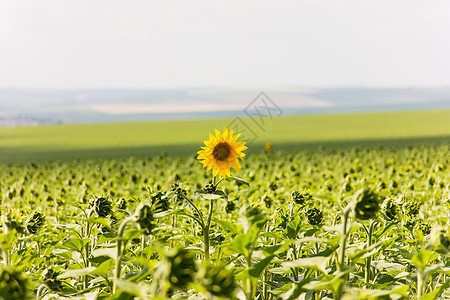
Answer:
[{"left": 200, "top": 266, "right": 236, "bottom": 298}]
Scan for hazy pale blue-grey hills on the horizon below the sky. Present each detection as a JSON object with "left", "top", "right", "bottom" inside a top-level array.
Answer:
[{"left": 0, "top": 87, "right": 450, "bottom": 126}]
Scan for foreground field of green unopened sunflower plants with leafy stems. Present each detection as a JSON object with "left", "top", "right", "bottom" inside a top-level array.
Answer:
[{"left": 0, "top": 110, "right": 450, "bottom": 299}]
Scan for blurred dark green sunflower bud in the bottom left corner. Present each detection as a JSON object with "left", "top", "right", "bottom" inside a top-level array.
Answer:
[{"left": 0, "top": 269, "right": 28, "bottom": 300}]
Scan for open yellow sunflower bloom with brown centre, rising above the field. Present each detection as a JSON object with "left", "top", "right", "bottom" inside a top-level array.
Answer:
[{"left": 197, "top": 128, "right": 247, "bottom": 178}]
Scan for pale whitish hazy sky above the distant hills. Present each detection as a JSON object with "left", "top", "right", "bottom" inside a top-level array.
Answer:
[{"left": 0, "top": 0, "right": 450, "bottom": 88}]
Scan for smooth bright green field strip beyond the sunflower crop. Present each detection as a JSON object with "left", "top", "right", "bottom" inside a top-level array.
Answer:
[{"left": 0, "top": 110, "right": 450, "bottom": 163}]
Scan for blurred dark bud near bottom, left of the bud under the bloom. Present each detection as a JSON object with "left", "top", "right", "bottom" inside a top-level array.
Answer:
[{"left": 167, "top": 249, "right": 197, "bottom": 289}]
